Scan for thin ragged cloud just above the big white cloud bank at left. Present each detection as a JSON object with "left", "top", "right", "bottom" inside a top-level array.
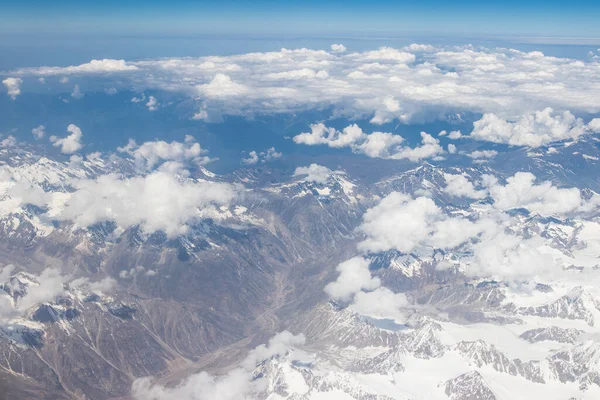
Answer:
[{"left": 117, "top": 135, "right": 212, "bottom": 171}]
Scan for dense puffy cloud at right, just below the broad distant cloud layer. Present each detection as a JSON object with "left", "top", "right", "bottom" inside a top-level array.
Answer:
[{"left": 471, "top": 107, "right": 589, "bottom": 147}]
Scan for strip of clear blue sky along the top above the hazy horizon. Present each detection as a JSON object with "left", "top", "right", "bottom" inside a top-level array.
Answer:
[{"left": 0, "top": 0, "right": 600, "bottom": 37}]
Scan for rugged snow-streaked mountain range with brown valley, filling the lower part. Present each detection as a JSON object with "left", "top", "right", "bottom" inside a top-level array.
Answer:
[{"left": 0, "top": 132, "right": 600, "bottom": 400}]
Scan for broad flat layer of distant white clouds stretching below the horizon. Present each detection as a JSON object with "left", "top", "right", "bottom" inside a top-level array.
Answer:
[{"left": 10, "top": 44, "right": 600, "bottom": 130}]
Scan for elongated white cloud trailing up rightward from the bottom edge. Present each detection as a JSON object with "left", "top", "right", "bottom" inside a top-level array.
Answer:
[{"left": 132, "top": 331, "right": 305, "bottom": 400}]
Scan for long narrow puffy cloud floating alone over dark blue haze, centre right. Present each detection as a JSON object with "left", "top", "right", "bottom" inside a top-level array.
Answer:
[{"left": 293, "top": 123, "right": 444, "bottom": 161}]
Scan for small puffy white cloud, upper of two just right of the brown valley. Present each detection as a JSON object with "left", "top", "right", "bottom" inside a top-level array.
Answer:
[{"left": 325, "top": 257, "right": 381, "bottom": 302}]
